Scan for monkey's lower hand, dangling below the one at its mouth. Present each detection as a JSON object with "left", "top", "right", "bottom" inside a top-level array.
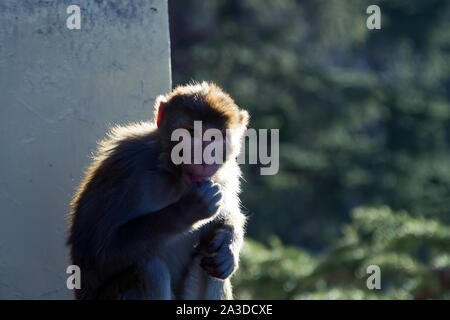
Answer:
[{"left": 200, "top": 227, "right": 239, "bottom": 280}]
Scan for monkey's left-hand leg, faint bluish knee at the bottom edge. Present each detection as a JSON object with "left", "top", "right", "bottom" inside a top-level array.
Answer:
[{"left": 142, "top": 256, "right": 173, "bottom": 300}]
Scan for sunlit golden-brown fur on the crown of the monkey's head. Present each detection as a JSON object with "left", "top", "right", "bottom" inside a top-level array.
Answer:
[{"left": 155, "top": 81, "right": 249, "bottom": 130}]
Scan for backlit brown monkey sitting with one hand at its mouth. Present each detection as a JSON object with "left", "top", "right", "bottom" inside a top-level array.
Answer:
[{"left": 68, "top": 82, "right": 249, "bottom": 299}]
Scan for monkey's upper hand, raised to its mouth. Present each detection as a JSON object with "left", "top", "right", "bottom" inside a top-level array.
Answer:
[{"left": 181, "top": 181, "right": 222, "bottom": 223}]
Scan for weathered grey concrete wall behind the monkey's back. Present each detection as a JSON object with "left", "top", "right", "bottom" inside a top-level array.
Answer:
[{"left": 0, "top": 0, "right": 171, "bottom": 299}]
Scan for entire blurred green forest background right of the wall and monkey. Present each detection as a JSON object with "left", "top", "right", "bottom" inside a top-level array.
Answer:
[{"left": 169, "top": 0, "right": 450, "bottom": 299}]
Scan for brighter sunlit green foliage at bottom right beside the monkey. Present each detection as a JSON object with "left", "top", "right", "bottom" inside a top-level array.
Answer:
[{"left": 233, "top": 207, "right": 450, "bottom": 299}]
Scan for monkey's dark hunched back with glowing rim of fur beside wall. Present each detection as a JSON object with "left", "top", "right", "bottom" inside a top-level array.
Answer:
[{"left": 67, "top": 122, "right": 159, "bottom": 299}]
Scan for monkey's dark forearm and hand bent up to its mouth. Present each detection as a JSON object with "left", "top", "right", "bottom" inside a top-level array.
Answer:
[{"left": 97, "top": 182, "right": 221, "bottom": 269}]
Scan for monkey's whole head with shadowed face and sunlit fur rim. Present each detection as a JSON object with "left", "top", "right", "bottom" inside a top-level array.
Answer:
[{"left": 155, "top": 82, "right": 249, "bottom": 183}]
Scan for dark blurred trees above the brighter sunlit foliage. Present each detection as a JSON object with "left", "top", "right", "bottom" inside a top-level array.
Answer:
[{"left": 169, "top": 0, "right": 450, "bottom": 249}]
